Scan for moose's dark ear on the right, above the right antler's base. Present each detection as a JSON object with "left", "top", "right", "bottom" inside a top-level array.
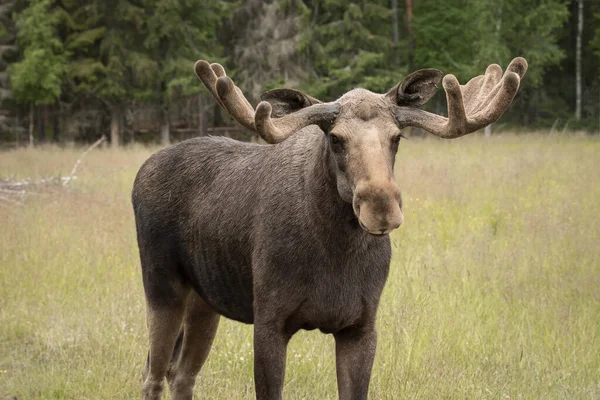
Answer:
[{"left": 386, "top": 69, "right": 443, "bottom": 107}]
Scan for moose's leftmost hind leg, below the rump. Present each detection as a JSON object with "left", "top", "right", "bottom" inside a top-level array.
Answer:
[{"left": 142, "top": 283, "right": 189, "bottom": 400}]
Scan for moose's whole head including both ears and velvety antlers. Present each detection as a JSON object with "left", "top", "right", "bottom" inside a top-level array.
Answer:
[{"left": 195, "top": 57, "right": 527, "bottom": 235}]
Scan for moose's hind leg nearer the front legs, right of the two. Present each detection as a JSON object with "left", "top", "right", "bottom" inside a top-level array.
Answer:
[{"left": 167, "top": 293, "right": 220, "bottom": 400}]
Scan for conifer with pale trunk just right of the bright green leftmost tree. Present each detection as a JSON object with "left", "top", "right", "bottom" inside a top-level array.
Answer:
[{"left": 66, "top": 0, "right": 148, "bottom": 146}]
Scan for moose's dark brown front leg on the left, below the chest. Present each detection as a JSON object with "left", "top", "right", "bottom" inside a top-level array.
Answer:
[{"left": 254, "top": 321, "right": 291, "bottom": 400}]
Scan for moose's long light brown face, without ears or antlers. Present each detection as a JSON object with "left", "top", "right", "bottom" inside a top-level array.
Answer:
[{"left": 327, "top": 89, "right": 404, "bottom": 235}]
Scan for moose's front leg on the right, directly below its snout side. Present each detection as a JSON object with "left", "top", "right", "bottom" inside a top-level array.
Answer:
[{"left": 335, "top": 326, "right": 377, "bottom": 400}]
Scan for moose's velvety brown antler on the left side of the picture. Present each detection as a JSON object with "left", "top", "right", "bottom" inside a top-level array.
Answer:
[{"left": 194, "top": 60, "right": 339, "bottom": 143}]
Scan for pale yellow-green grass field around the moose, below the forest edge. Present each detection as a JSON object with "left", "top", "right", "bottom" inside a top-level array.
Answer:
[{"left": 0, "top": 135, "right": 600, "bottom": 400}]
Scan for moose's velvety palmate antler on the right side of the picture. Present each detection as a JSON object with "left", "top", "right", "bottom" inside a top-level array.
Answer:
[{"left": 396, "top": 57, "right": 527, "bottom": 139}]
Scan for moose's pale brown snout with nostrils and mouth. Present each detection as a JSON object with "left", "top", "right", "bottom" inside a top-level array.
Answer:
[{"left": 352, "top": 182, "right": 404, "bottom": 235}]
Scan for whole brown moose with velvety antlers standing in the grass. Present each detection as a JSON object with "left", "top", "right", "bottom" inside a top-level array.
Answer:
[{"left": 132, "top": 57, "right": 527, "bottom": 400}]
